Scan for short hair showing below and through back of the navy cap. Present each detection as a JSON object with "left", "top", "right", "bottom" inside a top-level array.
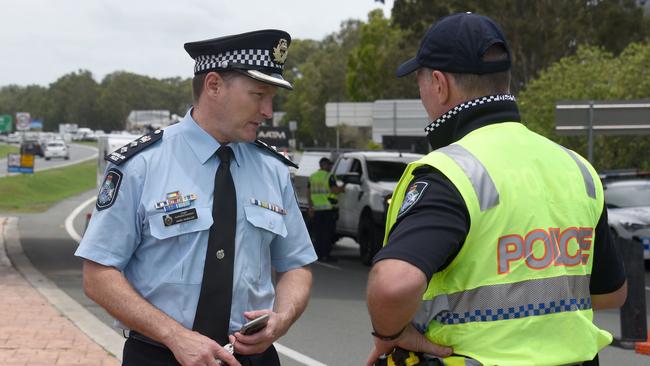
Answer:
[{"left": 447, "top": 43, "right": 510, "bottom": 100}]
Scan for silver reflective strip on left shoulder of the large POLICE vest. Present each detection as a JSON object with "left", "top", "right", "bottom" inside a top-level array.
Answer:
[{"left": 437, "top": 144, "right": 499, "bottom": 211}]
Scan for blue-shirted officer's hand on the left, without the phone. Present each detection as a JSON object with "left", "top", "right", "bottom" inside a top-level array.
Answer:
[{"left": 164, "top": 329, "right": 241, "bottom": 366}]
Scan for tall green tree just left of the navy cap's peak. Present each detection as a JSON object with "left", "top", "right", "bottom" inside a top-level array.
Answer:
[{"left": 347, "top": 9, "right": 418, "bottom": 101}]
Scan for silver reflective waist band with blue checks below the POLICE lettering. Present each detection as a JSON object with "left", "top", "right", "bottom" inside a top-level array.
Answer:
[{"left": 414, "top": 276, "right": 591, "bottom": 329}]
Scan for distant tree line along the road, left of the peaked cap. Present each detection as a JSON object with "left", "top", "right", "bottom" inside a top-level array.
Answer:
[{"left": 0, "top": 70, "right": 192, "bottom": 131}]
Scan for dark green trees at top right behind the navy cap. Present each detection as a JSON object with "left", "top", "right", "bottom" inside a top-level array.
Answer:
[{"left": 392, "top": 0, "right": 650, "bottom": 91}]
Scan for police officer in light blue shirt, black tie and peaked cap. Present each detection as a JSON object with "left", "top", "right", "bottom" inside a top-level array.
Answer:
[{"left": 75, "top": 30, "right": 316, "bottom": 366}]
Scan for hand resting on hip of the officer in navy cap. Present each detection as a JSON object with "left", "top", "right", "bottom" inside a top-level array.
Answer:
[{"left": 366, "top": 324, "right": 453, "bottom": 366}]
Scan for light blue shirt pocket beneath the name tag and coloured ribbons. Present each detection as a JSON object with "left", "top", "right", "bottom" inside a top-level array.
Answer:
[{"left": 148, "top": 207, "right": 213, "bottom": 285}]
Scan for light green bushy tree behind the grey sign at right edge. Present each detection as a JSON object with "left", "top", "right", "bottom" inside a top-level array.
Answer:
[{"left": 519, "top": 43, "right": 650, "bottom": 170}]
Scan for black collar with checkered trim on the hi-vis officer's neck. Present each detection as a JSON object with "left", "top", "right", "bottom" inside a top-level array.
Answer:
[{"left": 424, "top": 94, "right": 521, "bottom": 150}]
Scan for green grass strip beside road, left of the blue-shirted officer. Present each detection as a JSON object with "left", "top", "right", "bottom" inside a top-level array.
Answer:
[{"left": 0, "top": 160, "right": 97, "bottom": 212}]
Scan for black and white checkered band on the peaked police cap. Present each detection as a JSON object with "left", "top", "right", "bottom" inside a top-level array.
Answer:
[{"left": 194, "top": 49, "right": 284, "bottom": 74}]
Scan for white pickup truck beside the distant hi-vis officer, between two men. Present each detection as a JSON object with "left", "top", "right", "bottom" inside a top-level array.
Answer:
[{"left": 332, "top": 151, "right": 423, "bottom": 265}]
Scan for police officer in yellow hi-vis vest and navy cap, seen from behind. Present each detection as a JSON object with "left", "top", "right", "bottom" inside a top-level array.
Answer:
[{"left": 367, "top": 13, "right": 627, "bottom": 365}]
